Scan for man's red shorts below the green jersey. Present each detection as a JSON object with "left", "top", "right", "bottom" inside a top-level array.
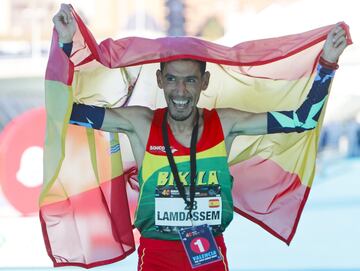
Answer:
[{"left": 138, "top": 235, "right": 229, "bottom": 271}]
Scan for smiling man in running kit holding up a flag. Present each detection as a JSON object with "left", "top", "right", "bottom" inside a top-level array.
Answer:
[{"left": 53, "top": 4, "right": 347, "bottom": 270}]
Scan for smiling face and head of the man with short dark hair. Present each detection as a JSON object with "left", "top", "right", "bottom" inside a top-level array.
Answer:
[{"left": 156, "top": 60, "right": 210, "bottom": 121}]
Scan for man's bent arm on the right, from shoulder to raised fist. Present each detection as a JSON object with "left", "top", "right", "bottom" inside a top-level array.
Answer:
[{"left": 219, "top": 25, "right": 347, "bottom": 136}]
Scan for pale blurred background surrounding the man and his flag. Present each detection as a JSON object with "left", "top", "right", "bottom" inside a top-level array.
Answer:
[{"left": 0, "top": 0, "right": 360, "bottom": 271}]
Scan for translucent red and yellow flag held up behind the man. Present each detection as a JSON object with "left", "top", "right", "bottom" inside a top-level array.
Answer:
[{"left": 40, "top": 5, "right": 351, "bottom": 268}]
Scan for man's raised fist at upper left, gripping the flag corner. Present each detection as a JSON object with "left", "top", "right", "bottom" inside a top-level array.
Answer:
[{"left": 53, "top": 4, "right": 76, "bottom": 43}]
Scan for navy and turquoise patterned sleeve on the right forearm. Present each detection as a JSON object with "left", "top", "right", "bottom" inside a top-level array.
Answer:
[{"left": 267, "top": 63, "right": 335, "bottom": 133}]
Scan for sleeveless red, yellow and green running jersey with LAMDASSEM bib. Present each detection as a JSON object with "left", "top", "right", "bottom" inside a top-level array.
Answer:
[{"left": 134, "top": 108, "right": 233, "bottom": 240}]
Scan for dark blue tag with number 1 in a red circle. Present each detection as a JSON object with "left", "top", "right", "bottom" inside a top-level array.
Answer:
[{"left": 179, "top": 224, "right": 222, "bottom": 268}]
